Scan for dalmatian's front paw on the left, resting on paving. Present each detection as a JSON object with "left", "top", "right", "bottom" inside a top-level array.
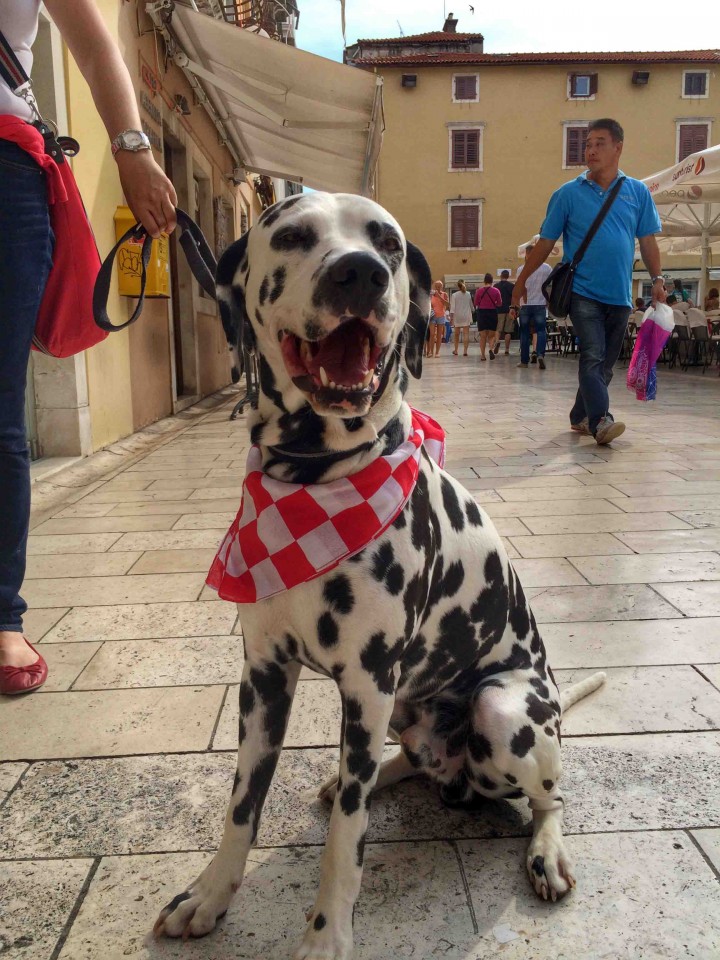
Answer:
[{"left": 153, "top": 863, "right": 239, "bottom": 940}]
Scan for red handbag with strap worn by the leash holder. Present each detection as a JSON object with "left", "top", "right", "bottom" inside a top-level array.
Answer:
[{"left": 0, "top": 33, "right": 107, "bottom": 357}]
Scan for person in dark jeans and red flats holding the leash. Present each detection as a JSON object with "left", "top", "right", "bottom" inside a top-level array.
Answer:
[{"left": 0, "top": 0, "right": 177, "bottom": 694}]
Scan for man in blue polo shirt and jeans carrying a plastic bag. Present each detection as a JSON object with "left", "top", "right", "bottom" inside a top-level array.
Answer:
[{"left": 512, "top": 119, "right": 665, "bottom": 444}]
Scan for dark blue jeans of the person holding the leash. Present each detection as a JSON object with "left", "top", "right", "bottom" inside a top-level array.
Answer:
[{"left": 0, "top": 140, "right": 53, "bottom": 632}]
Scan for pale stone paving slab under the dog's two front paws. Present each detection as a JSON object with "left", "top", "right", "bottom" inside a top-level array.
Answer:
[{"left": 60, "top": 843, "right": 473, "bottom": 960}]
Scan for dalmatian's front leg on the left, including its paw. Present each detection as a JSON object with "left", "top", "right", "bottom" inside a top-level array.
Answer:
[{"left": 154, "top": 661, "right": 300, "bottom": 939}]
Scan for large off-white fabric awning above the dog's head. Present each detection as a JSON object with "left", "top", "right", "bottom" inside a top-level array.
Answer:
[{"left": 163, "top": 3, "right": 383, "bottom": 195}]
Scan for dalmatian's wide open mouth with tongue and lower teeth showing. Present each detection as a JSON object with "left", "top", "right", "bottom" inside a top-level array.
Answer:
[{"left": 280, "top": 317, "right": 387, "bottom": 404}]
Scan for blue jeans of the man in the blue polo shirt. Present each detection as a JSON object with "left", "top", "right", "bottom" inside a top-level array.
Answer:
[{"left": 570, "top": 293, "right": 631, "bottom": 434}]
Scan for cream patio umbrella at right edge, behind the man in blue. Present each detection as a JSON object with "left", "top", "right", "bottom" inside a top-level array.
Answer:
[{"left": 643, "top": 147, "right": 720, "bottom": 303}]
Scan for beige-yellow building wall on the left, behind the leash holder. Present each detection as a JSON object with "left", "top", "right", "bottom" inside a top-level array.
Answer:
[{"left": 27, "top": 0, "right": 272, "bottom": 458}]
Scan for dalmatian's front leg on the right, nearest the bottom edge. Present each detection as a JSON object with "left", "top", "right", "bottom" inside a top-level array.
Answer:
[{"left": 295, "top": 670, "right": 395, "bottom": 960}]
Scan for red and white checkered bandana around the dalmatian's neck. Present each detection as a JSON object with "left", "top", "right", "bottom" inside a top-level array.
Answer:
[{"left": 207, "top": 408, "right": 445, "bottom": 603}]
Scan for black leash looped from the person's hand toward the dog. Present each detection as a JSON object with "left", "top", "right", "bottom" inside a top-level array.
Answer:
[{"left": 93, "top": 207, "right": 217, "bottom": 332}]
